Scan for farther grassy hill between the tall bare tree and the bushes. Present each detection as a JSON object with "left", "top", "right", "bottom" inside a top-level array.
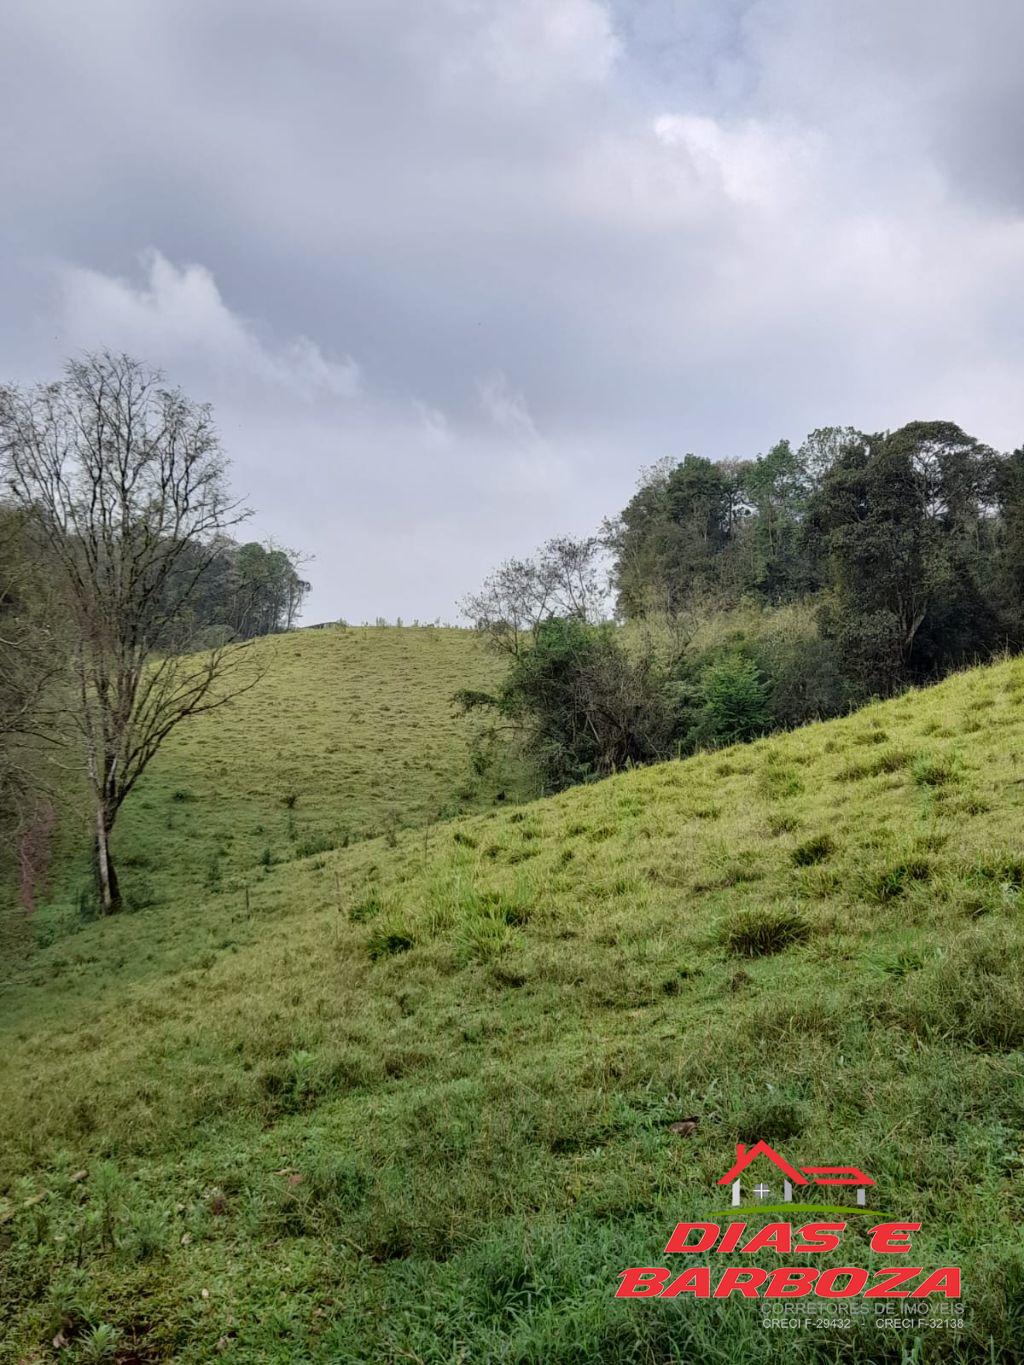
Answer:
[{"left": 25, "top": 627, "right": 526, "bottom": 932}]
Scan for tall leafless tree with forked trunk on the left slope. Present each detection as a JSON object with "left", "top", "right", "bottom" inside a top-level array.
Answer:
[{"left": 0, "top": 352, "right": 255, "bottom": 913}]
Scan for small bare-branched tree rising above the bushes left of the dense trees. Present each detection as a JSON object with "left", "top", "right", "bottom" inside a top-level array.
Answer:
[{"left": 460, "top": 535, "right": 608, "bottom": 658}]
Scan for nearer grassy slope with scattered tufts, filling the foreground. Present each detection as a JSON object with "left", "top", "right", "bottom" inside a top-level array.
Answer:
[{"left": 0, "top": 657, "right": 1024, "bottom": 1365}]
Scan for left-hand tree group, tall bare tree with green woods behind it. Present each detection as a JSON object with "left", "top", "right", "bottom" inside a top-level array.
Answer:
[{"left": 0, "top": 352, "right": 309, "bottom": 913}]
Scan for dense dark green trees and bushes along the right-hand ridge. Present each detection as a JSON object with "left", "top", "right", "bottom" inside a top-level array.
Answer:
[{"left": 460, "top": 422, "right": 1024, "bottom": 788}]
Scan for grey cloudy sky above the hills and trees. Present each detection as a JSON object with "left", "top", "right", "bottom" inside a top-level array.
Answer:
[{"left": 0, "top": 0, "right": 1024, "bottom": 621}]
